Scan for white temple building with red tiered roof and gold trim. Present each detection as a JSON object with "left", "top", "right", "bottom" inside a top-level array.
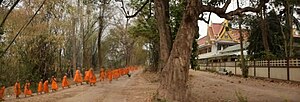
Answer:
[{"left": 197, "top": 20, "right": 249, "bottom": 60}]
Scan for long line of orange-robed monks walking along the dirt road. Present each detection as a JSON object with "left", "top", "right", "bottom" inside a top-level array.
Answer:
[{"left": 0, "top": 66, "right": 138, "bottom": 101}]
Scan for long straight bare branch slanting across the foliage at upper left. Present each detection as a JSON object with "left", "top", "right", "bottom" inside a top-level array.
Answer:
[{"left": 0, "top": 0, "right": 46, "bottom": 57}]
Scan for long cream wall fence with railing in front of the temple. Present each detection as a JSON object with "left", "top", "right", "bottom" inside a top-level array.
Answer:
[{"left": 199, "top": 58, "right": 300, "bottom": 81}]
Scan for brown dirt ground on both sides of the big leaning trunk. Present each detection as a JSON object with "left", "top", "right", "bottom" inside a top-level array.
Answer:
[{"left": 2, "top": 70, "right": 300, "bottom": 102}]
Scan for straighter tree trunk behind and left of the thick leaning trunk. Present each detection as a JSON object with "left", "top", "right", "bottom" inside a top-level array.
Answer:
[{"left": 154, "top": 0, "right": 172, "bottom": 71}]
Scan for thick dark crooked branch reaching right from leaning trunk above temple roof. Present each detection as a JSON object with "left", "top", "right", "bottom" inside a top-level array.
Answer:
[{"left": 200, "top": 0, "right": 269, "bottom": 20}]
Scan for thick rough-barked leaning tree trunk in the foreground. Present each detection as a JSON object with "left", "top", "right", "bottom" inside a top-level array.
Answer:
[{"left": 158, "top": 0, "right": 200, "bottom": 102}]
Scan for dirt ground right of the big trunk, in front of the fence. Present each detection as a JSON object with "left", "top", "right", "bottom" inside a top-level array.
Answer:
[{"left": 190, "top": 70, "right": 300, "bottom": 102}]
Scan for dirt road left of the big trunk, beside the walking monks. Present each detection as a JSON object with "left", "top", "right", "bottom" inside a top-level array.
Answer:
[{"left": 6, "top": 70, "right": 157, "bottom": 102}]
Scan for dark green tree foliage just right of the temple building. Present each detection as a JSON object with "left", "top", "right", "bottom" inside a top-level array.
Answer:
[{"left": 248, "top": 10, "right": 285, "bottom": 59}]
